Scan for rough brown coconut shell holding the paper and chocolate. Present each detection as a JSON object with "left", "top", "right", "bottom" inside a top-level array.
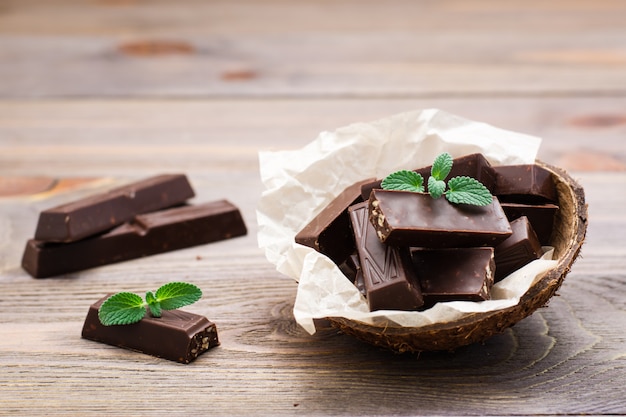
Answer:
[{"left": 329, "top": 161, "right": 587, "bottom": 353}]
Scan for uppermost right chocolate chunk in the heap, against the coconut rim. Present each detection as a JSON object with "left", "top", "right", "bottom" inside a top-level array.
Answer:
[{"left": 493, "top": 164, "right": 558, "bottom": 204}]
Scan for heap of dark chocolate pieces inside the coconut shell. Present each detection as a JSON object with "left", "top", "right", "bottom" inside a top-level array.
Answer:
[{"left": 295, "top": 154, "right": 558, "bottom": 311}]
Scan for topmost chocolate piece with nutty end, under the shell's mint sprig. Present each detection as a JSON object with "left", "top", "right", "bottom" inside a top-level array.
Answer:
[{"left": 369, "top": 190, "right": 512, "bottom": 248}]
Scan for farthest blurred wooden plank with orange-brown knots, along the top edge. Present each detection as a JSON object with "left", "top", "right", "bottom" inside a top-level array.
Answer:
[{"left": 0, "top": 0, "right": 626, "bottom": 98}]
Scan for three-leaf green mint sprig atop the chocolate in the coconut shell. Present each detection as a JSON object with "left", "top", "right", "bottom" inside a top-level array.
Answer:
[{"left": 381, "top": 152, "right": 493, "bottom": 206}]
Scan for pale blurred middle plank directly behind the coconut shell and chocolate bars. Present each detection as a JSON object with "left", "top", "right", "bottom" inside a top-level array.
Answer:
[{"left": 0, "top": 97, "right": 626, "bottom": 176}]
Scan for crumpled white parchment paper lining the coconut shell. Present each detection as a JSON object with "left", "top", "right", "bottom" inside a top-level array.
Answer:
[{"left": 257, "top": 109, "right": 557, "bottom": 334}]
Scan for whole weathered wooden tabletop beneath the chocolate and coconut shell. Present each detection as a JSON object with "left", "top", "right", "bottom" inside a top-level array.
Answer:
[{"left": 0, "top": 0, "right": 626, "bottom": 416}]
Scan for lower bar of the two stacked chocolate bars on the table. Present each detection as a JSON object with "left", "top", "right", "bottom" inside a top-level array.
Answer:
[{"left": 22, "top": 200, "right": 247, "bottom": 278}]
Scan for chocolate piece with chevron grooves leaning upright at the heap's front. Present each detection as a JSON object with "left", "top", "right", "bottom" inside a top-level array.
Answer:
[{"left": 348, "top": 202, "right": 423, "bottom": 311}]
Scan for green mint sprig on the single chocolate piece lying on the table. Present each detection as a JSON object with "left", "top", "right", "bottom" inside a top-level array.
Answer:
[{"left": 98, "top": 282, "right": 202, "bottom": 326}]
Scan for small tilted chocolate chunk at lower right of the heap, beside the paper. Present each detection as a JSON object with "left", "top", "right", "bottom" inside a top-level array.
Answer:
[{"left": 494, "top": 216, "right": 543, "bottom": 282}]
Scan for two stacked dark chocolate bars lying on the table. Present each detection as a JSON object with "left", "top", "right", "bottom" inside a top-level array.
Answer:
[{"left": 22, "top": 174, "right": 247, "bottom": 278}]
